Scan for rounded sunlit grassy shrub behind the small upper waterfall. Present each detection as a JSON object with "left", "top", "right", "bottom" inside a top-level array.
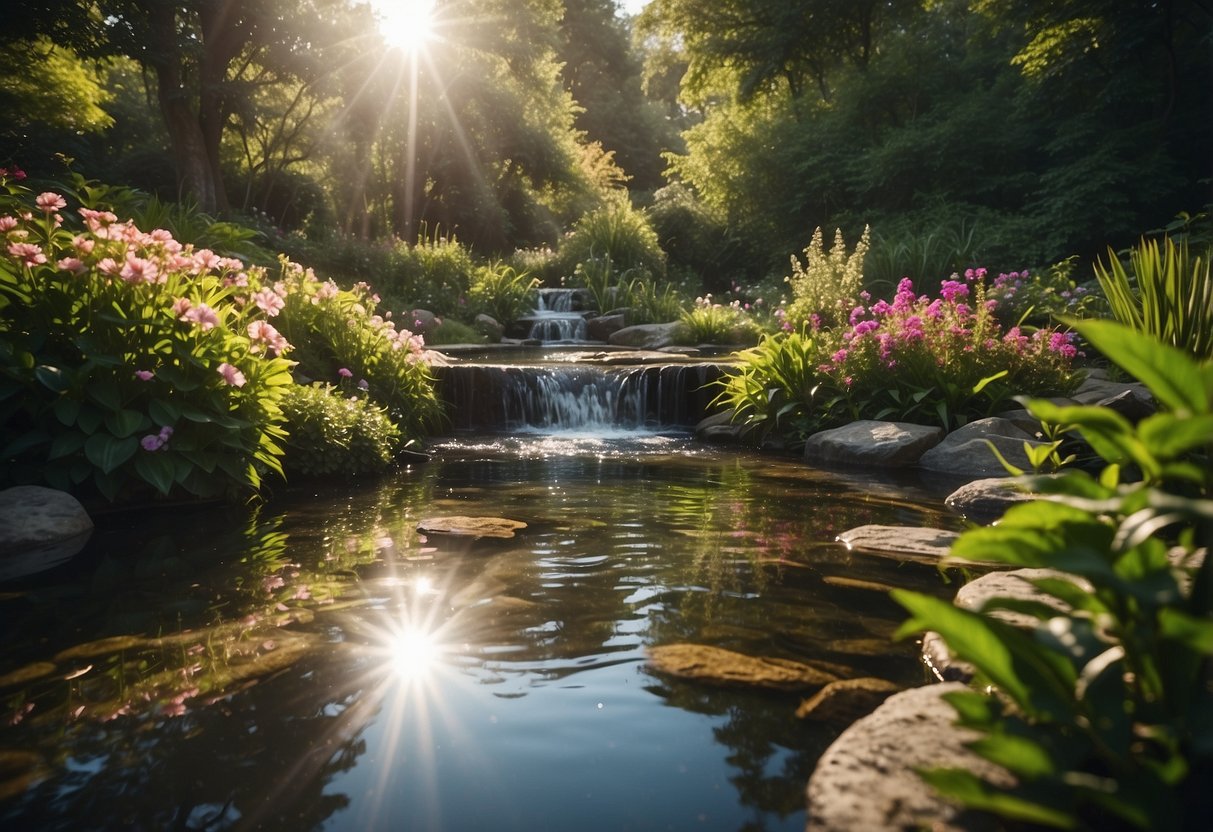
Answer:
[{"left": 559, "top": 200, "right": 666, "bottom": 278}]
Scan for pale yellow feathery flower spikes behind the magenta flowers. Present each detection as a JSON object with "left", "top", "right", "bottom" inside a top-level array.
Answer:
[{"left": 785, "top": 227, "right": 869, "bottom": 327}]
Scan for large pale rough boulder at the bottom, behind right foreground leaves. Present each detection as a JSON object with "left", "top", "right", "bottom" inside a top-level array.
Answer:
[{"left": 805, "top": 684, "right": 1014, "bottom": 832}]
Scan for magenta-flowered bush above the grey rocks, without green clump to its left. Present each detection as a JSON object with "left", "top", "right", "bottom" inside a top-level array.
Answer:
[{"left": 818, "top": 269, "right": 1078, "bottom": 428}]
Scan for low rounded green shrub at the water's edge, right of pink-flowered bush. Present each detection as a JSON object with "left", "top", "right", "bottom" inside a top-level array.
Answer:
[{"left": 281, "top": 382, "right": 400, "bottom": 477}]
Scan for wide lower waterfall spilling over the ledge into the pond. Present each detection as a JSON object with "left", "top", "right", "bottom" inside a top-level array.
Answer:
[{"left": 437, "top": 363, "right": 724, "bottom": 433}]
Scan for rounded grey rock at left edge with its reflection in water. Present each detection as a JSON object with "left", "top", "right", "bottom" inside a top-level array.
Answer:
[{"left": 0, "top": 485, "right": 92, "bottom": 581}]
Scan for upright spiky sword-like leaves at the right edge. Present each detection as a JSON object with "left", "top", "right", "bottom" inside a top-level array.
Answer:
[{"left": 1095, "top": 237, "right": 1213, "bottom": 360}]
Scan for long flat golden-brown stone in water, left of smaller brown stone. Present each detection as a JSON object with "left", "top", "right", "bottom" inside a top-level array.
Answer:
[{"left": 649, "top": 644, "right": 838, "bottom": 690}]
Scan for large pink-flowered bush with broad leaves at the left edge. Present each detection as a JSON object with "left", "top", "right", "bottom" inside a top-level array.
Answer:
[{"left": 0, "top": 177, "right": 291, "bottom": 500}]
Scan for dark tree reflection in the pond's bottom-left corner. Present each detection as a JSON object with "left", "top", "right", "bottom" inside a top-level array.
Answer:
[{"left": 0, "top": 660, "right": 369, "bottom": 831}]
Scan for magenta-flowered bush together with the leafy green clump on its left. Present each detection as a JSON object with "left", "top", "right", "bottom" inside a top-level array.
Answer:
[{"left": 716, "top": 269, "right": 1080, "bottom": 446}]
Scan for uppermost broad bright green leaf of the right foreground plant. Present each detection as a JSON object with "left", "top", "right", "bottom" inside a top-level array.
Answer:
[{"left": 1067, "top": 319, "right": 1209, "bottom": 415}]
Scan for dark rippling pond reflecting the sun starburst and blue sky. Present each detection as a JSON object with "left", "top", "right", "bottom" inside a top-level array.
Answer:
[{"left": 0, "top": 431, "right": 956, "bottom": 831}]
